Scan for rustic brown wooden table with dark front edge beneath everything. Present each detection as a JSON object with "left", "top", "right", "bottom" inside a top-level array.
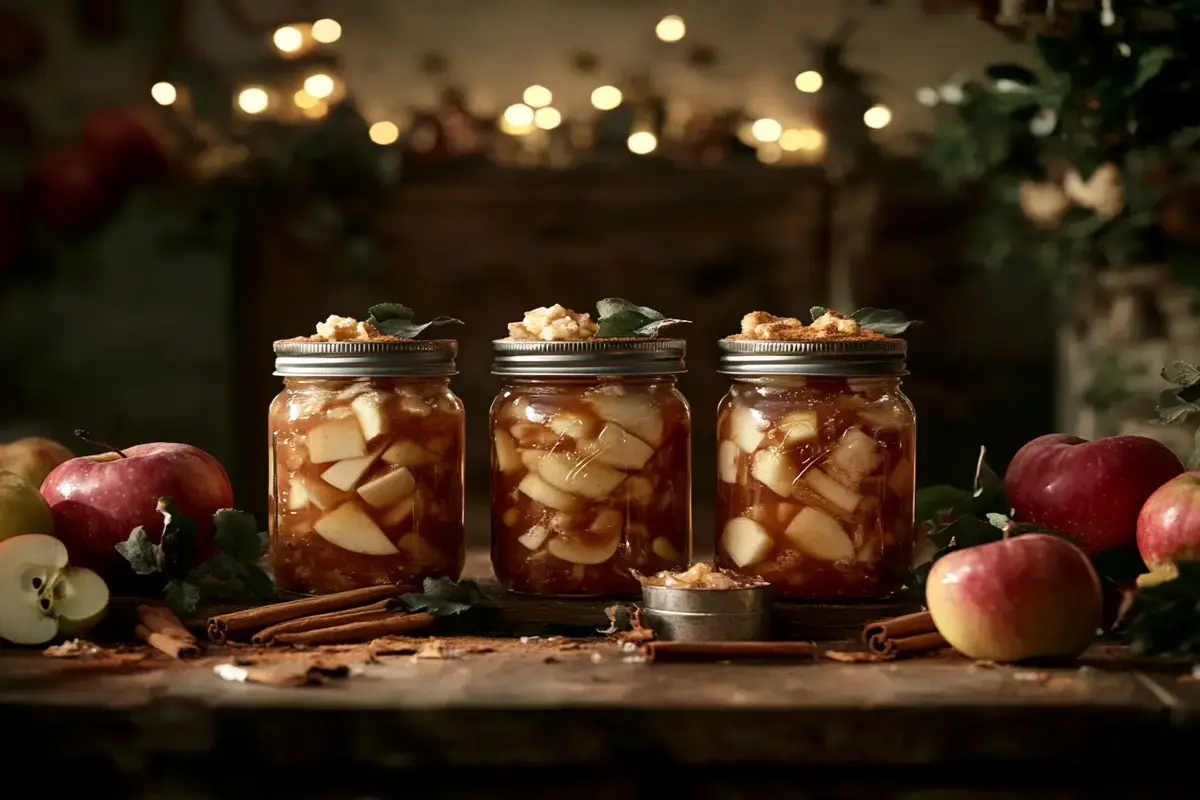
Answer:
[{"left": 0, "top": 554, "right": 1200, "bottom": 799}]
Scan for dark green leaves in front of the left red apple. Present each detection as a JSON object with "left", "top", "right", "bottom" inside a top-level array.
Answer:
[{"left": 116, "top": 498, "right": 275, "bottom": 616}]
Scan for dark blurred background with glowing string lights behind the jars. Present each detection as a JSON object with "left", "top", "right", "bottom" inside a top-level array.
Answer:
[{"left": 0, "top": 0, "right": 1200, "bottom": 542}]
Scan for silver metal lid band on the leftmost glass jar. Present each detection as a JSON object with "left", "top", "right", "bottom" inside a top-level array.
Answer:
[{"left": 275, "top": 339, "right": 458, "bottom": 378}]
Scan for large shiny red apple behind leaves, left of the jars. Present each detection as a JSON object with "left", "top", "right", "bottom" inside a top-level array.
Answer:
[{"left": 42, "top": 443, "right": 233, "bottom": 589}]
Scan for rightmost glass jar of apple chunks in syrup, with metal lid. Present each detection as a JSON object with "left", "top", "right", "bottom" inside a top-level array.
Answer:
[{"left": 716, "top": 339, "right": 917, "bottom": 600}]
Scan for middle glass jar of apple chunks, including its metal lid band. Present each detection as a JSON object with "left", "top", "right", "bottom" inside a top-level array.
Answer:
[{"left": 491, "top": 339, "right": 691, "bottom": 596}]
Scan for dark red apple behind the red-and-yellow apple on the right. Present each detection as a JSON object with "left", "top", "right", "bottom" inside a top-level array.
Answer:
[{"left": 1004, "top": 433, "right": 1183, "bottom": 555}]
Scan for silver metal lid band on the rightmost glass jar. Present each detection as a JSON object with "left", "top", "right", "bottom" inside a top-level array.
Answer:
[{"left": 716, "top": 339, "right": 908, "bottom": 378}]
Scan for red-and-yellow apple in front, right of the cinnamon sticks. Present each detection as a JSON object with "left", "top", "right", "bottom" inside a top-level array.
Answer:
[{"left": 925, "top": 534, "right": 1102, "bottom": 661}]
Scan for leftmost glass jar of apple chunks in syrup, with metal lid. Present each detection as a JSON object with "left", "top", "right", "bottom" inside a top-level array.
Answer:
[{"left": 268, "top": 339, "right": 466, "bottom": 594}]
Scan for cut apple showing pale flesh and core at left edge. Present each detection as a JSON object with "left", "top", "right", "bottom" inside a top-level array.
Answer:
[{"left": 0, "top": 534, "right": 108, "bottom": 644}]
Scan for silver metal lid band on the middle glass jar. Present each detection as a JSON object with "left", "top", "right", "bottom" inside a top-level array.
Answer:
[{"left": 492, "top": 338, "right": 686, "bottom": 378}]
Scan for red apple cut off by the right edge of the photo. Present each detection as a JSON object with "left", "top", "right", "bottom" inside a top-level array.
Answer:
[{"left": 1138, "top": 470, "right": 1200, "bottom": 570}]
